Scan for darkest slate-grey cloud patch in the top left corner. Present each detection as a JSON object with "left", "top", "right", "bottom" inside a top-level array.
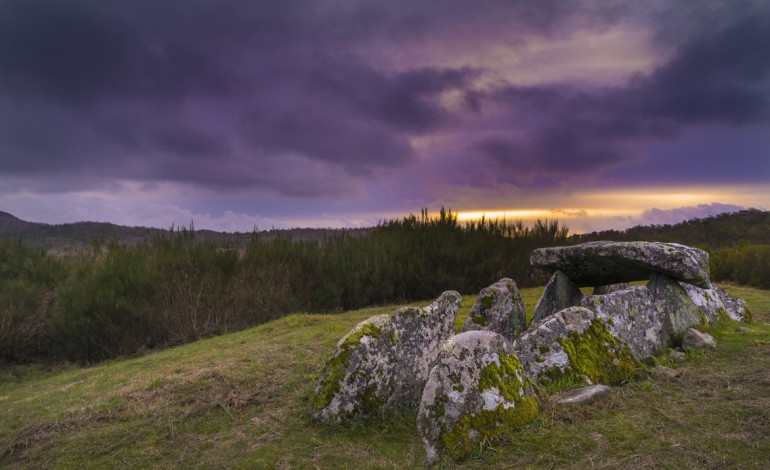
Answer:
[{"left": 0, "top": 0, "right": 237, "bottom": 106}]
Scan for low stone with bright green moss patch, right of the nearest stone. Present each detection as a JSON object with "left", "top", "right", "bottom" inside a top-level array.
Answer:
[{"left": 513, "top": 307, "right": 642, "bottom": 385}]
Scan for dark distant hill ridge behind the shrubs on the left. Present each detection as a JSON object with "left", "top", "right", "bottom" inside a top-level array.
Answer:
[{"left": 0, "top": 211, "right": 372, "bottom": 255}]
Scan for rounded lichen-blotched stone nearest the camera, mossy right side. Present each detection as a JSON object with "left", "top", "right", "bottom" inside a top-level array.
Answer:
[{"left": 417, "top": 331, "right": 539, "bottom": 464}]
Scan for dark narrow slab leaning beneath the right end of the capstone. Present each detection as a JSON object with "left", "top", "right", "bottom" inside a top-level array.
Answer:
[{"left": 647, "top": 273, "right": 705, "bottom": 335}]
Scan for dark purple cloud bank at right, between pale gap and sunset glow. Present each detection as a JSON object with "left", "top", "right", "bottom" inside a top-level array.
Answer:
[{"left": 469, "top": 4, "right": 770, "bottom": 182}]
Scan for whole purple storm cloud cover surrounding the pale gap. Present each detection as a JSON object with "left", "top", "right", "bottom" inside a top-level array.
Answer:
[{"left": 0, "top": 0, "right": 770, "bottom": 197}]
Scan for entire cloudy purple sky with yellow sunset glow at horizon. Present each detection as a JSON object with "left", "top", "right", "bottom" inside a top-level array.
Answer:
[{"left": 0, "top": 0, "right": 770, "bottom": 232}]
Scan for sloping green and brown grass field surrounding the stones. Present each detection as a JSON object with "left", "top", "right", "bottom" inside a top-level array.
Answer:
[{"left": 0, "top": 286, "right": 770, "bottom": 469}]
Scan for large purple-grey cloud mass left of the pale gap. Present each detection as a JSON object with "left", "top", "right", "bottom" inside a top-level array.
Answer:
[{"left": 0, "top": 0, "right": 504, "bottom": 193}]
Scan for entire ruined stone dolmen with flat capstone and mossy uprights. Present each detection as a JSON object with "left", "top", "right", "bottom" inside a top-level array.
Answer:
[{"left": 309, "top": 241, "right": 751, "bottom": 465}]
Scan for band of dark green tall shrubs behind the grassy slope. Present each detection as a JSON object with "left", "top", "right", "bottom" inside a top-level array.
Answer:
[{"left": 0, "top": 209, "right": 568, "bottom": 362}]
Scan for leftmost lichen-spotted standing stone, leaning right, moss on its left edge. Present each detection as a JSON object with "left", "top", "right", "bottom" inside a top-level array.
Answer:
[{"left": 310, "top": 291, "right": 461, "bottom": 423}]
